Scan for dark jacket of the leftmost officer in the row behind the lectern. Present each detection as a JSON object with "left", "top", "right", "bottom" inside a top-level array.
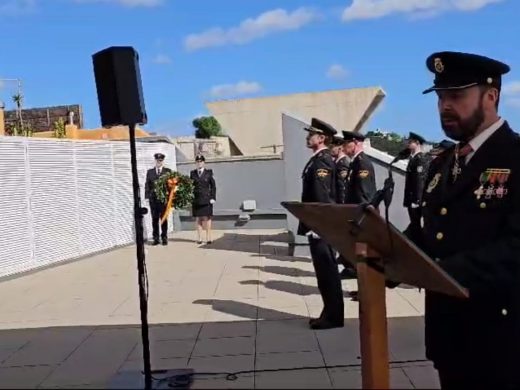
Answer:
[{"left": 298, "top": 149, "right": 336, "bottom": 236}]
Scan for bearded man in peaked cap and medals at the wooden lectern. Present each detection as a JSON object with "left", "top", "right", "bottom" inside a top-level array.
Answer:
[{"left": 406, "top": 52, "right": 520, "bottom": 389}]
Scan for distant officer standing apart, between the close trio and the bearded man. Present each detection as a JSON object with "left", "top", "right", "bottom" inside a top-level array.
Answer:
[{"left": 403, "top": 132, "right": 430, "bottom": 235}]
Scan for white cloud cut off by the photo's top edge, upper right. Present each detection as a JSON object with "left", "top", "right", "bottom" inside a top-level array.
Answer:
[{"left": 342, "top": 0, "right": 504, "bottom": 22}]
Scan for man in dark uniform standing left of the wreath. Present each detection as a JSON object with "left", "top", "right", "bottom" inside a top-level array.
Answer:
[{"left": 144, "top": 153, "right": 171, "bottom": 245}]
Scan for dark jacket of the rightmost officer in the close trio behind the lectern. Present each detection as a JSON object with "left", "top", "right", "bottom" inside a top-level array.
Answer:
[{"left": 345, "top": 152, "right": 377, "bottom": 204}]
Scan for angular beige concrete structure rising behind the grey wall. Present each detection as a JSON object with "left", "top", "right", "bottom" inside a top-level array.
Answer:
[{"left": 206, "top": 87, "right": 385, "bottom": 155}]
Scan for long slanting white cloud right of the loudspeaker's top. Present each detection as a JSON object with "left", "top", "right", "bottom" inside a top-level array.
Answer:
[{"left": 184, "top": 8, "right": 319, "bottom": 51}]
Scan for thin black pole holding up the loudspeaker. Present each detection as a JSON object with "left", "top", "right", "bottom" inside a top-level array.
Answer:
[{"left": 128, "top": 124, "right": 152, "bottom": 390}]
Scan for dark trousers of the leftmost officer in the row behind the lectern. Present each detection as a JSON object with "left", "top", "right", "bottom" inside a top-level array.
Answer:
[{"left": 309, "top": 237, "right": 345, "bottom": 323}]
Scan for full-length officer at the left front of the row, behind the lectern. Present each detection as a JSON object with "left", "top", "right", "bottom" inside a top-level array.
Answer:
[{"left": 298, "top": 118, "right": 344, "bottom": 329}]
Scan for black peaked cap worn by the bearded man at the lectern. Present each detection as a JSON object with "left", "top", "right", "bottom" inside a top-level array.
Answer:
[{"left": 423, "top": 51, "right": 510, "bottom": 94}]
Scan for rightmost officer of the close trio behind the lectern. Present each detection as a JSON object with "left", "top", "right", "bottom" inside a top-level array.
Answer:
[{"left": 343, "top": 131, "right": 377, "bottom": 204}]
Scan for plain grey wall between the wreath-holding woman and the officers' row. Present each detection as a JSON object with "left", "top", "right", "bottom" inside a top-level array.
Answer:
[{"left": 177, "top": 155, "right": 286, "bottom": 230}]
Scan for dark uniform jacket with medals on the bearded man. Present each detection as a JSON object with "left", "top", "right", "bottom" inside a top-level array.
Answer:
[{"left": 405, "top": 122, "right": 520, "bottom": 378}]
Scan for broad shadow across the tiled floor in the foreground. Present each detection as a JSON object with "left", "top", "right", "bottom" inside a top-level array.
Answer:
[{"left": 0, "top": 312, "right": 438, "bottom": 388}]
